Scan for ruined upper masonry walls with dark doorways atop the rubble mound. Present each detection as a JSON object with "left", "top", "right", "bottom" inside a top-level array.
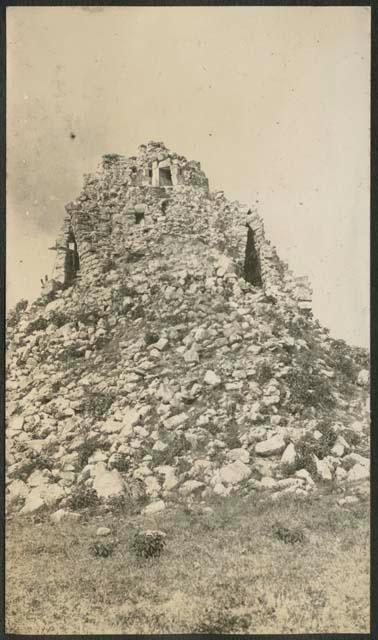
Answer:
[{"left": 43, "top": 142, "right": 311, "bottom": 311}]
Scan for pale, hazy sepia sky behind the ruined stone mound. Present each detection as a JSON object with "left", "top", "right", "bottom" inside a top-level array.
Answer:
[{"left": 7, "top": 7, "right": 370, "bottom": 346}]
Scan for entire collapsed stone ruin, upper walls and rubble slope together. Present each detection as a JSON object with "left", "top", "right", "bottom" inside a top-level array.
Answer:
[{"left": 7, "top": 142, "right": 369, "bottom": 519}]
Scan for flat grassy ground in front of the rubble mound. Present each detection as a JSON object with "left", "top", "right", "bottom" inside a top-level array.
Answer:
[{"left": 6, "top": 494, "right": 369, "bottom": 634}]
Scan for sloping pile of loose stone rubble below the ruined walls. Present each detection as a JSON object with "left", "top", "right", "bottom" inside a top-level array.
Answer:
[{"left": 6, "top": 145, "right": 369, "bottom": 521}]
